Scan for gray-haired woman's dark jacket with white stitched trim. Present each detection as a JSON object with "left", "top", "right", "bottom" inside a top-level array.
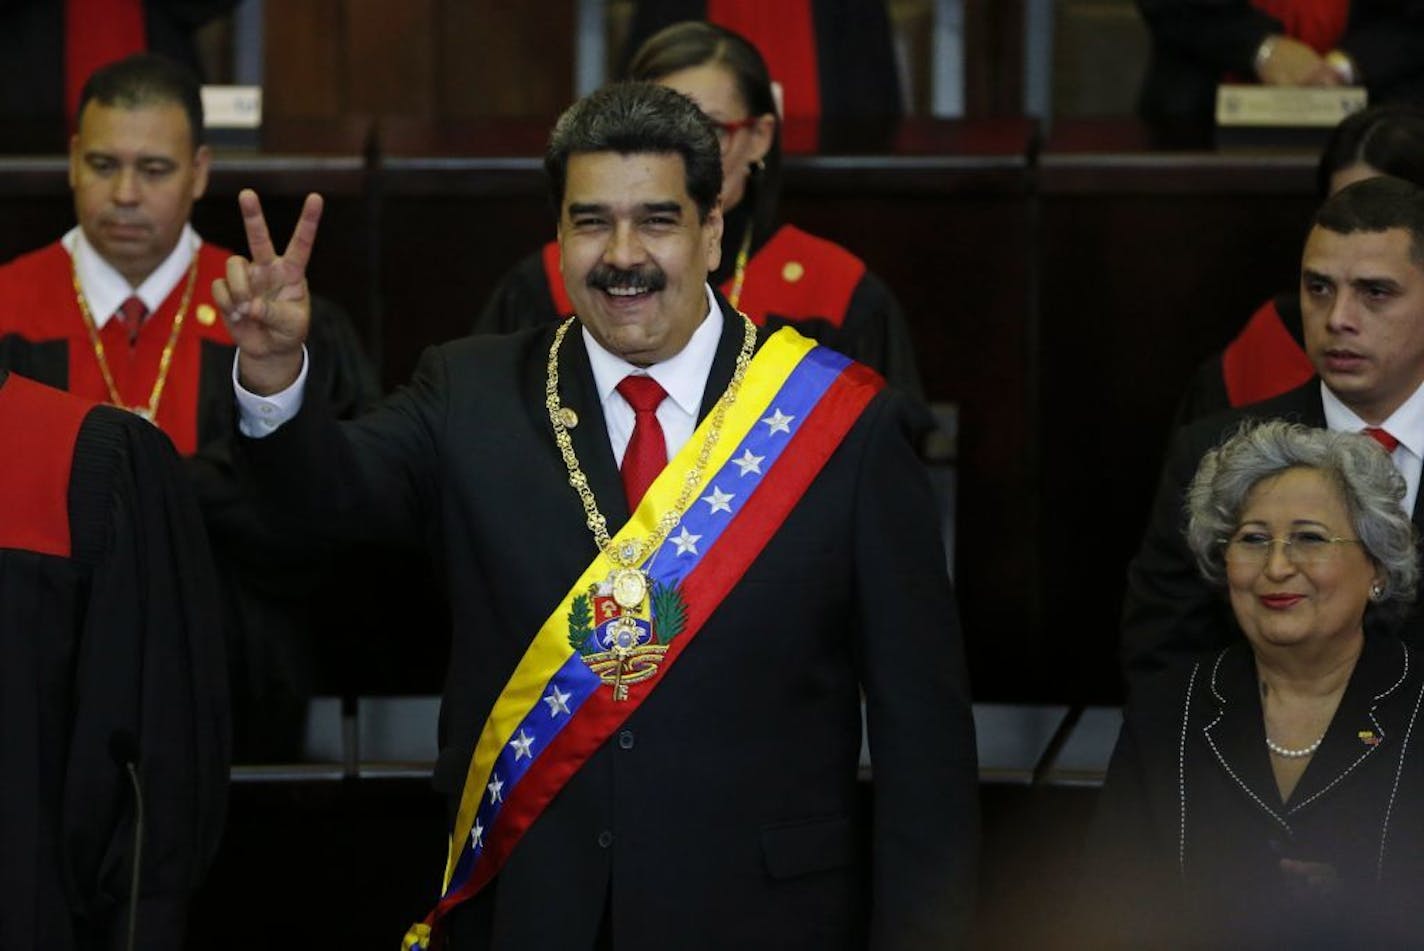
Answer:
[{"left": 1079, "top": 635, "right": 1424, "bottom": 948}]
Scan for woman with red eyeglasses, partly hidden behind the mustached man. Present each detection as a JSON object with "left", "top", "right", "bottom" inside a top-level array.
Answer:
[{"left": 474, "top": 21, "right": 928, "bottom": 426}]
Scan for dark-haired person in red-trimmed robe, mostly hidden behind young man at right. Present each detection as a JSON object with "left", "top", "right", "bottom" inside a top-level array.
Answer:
[{"left": 1176, "top": 104, "right": 1424, "bottom": 426}]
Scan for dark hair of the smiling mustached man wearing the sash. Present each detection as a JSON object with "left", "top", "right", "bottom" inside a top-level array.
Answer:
[{"left": 544, "top": 83, "right": 722, "bottom": 221}]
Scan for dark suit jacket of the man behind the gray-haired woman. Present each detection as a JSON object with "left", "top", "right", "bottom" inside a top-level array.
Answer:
[{"left": 1122, "top": 377, "right": 1424, "bottom": 686}]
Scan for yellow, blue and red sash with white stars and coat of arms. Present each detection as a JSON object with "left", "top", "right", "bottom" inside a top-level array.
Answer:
[{"left": 402, "top": 327, "right": 884, "bottom": 951}]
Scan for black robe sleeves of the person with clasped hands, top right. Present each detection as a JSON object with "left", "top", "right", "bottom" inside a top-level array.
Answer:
[{"left": 1138, "top": 0, "right": 1424, "bottom": 122}]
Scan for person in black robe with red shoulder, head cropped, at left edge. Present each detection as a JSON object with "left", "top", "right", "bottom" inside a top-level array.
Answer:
[{"left": 0, "top": 370, "right": 229, "bottom": 951}]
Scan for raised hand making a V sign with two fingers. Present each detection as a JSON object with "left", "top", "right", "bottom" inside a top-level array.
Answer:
[{"left": 212, "top": 188, "right": 322, "bottom": 394}]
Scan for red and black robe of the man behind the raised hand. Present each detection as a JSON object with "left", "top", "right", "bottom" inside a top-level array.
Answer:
[{"left": 0, "top": 228, "right": 376, "bottom": 760}]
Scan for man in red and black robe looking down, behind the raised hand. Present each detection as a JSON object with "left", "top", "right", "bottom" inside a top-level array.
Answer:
[{"left": 0, "top": 54, "right": 376, "bottom": 759}]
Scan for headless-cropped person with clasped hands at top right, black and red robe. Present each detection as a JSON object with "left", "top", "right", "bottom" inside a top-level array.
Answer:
[{"left": 1138, "top": 0, "right": 1424, "bottom": 121}]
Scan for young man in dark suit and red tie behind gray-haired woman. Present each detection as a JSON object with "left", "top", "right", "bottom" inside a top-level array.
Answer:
[{"left": 1122, "top": 178, "right": 1424, "bottom": 683}]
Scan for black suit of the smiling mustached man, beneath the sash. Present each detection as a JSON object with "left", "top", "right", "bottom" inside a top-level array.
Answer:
[{"left": 249, "top": 297, "right": 977, "bottom": 950}]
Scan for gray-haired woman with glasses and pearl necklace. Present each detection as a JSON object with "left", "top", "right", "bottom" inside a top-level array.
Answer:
[{"left": 1085, "top": 420, "right": 1424, "bottom": 947}]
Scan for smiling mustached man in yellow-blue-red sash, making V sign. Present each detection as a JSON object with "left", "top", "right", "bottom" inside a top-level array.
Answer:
[{"left": 207, "top": 84, "right": 977, "bottom": 950}]
